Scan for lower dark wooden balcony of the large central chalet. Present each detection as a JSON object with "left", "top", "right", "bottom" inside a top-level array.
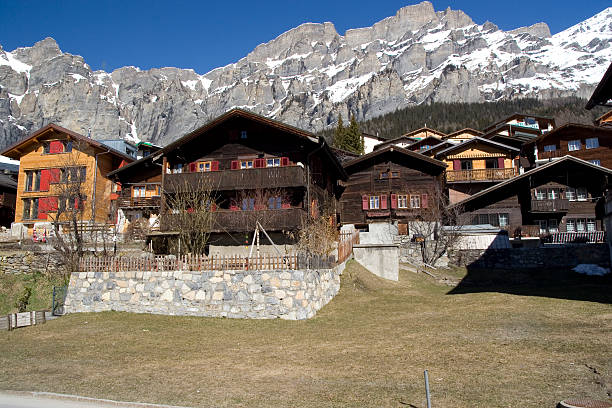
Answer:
[{"left": 161, "top": 207, "right": 306, "bottom": 232}]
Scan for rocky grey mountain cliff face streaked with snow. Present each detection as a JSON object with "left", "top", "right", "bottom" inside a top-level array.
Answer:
[{"left": 0, "top": 2, "right": 612, "bottom": 146}]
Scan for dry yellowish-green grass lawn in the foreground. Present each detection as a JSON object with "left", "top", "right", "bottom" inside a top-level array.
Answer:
[{"left": 0, "top": 262, "right": 612, "bottom": 407}]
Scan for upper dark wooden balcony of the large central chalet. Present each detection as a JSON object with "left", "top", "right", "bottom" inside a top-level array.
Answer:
[{"left": 164, "top": 166, "right": 306, "bottom": 193}]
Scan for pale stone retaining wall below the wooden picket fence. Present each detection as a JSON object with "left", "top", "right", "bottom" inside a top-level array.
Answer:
[{"left": 66, "top": 263, "right": 345, "bottom": 320}]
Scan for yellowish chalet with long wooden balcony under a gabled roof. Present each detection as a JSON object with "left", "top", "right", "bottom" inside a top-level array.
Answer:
[{"left": 435, "top": 136, "right": 520, "bottom": 203}]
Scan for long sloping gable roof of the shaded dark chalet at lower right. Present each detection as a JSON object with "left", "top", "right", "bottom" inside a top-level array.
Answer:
[{"left": 449, "top": 156, "right": 612, "bottom": 211}]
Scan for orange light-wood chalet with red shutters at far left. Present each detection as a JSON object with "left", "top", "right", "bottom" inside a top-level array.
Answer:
[{"left": 0, "top": 124, "right": 133, "bottom": 233}]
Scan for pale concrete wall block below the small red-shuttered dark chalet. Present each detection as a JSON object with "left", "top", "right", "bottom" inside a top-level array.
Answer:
[{"left": 353, "top": 244, "right": 399, "bottom": 281}]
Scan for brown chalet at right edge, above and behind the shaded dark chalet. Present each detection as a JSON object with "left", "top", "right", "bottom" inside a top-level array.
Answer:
[{"left": 523, "top": 123, "right": 612, "bottom": 169}]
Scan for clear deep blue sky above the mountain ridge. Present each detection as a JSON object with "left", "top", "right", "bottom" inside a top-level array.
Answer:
[{"left": 0, "top": 0, "right": 611, "bottom": 74}]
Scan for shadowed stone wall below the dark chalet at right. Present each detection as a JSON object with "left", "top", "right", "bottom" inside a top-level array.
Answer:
[{"left": 450, "top": 244, "right": 610, "bottom": 269}]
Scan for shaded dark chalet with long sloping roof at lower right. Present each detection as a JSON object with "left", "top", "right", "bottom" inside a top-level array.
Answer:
[{"left": 451, "top": 156, "right": 612, "bottom": 242}]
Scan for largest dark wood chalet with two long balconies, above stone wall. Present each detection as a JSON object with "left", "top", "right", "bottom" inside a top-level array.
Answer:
[{"left": 134, "top": 109, "right": 346, "bottom": 241}]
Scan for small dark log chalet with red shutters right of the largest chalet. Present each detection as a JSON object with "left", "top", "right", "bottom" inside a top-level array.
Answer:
[{"left": 340, "top": 146, "right": 446, "bottom": 226}]
